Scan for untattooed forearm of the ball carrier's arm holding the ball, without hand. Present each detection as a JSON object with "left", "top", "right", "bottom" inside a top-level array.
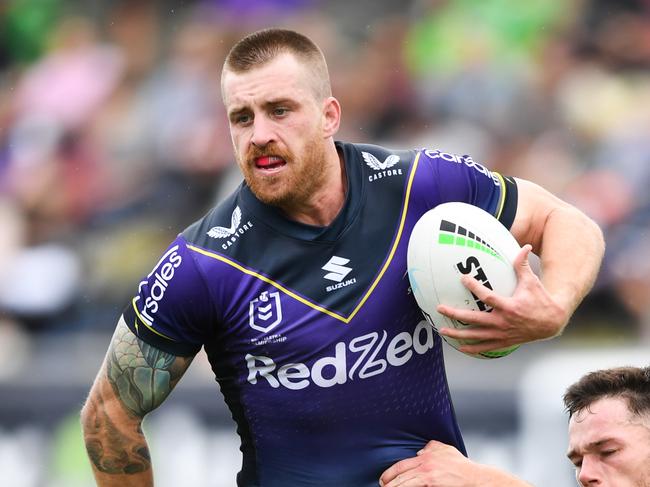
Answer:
[{"left": 540, "top": 206, "right": 605, "bottom": 324}]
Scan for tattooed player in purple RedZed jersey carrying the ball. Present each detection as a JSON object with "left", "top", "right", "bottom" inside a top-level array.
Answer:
[{"left": 82, "top": 29, "right": 604, "bottom": 487}]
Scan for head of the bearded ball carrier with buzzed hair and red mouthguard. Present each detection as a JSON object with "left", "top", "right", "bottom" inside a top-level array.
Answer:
[{"left": 221, "top": 29, "right": 340, "bottom": 207}]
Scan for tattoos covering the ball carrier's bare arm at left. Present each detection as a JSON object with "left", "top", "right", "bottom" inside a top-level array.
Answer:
[{"left": 84, "top": 322, "right": 192, "bottom": 474}]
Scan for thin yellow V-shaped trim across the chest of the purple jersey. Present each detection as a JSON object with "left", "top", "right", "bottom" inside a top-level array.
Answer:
[{"left": 185, "top": 152, "right": 420, "bottom": 326}]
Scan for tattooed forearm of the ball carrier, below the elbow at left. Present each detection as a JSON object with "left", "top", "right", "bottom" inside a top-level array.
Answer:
[{"left": 81, "top": 383, "right": 153, "bottom": 487}]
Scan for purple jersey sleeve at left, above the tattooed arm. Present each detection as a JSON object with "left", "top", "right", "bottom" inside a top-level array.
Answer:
[{"left": 124, "top": 236, "right": 214, "bottom": 356}]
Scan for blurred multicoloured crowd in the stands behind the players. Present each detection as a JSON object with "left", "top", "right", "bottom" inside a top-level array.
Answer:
[{"left": 0, "top": 0, "right": 650, "bottom": 350}]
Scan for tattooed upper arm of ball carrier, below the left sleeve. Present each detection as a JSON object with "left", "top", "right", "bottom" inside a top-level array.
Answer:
[{"left": 102, "top": 318, "right": 193, "bottom": 417}]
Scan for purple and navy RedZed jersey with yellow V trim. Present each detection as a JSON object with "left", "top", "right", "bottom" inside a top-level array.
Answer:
[{"left": 125, "top": 143, "right": 517, "bottom": 487}]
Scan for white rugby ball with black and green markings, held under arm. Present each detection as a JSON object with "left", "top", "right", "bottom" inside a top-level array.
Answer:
[{"left": 407, "top": 202, "right": 520, "bottom": 358}]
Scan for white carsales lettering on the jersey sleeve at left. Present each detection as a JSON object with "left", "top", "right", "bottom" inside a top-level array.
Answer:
[{"left": 133, "top": 245, "right": 183, "bottom": 326}]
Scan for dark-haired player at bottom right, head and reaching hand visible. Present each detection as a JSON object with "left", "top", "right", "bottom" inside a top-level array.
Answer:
[{"left": 379, "top": 367, "right": 650, "bottom": 487}]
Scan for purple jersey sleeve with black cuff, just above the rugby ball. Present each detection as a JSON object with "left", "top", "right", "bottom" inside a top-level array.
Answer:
[{"left": 417, "top": 149, "right": 518, "bottom": 228}]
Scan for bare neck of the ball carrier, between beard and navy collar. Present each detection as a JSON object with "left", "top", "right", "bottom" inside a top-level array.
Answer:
[{"left": 282, "top": 143, "right": 347, "bottom": 227}]
